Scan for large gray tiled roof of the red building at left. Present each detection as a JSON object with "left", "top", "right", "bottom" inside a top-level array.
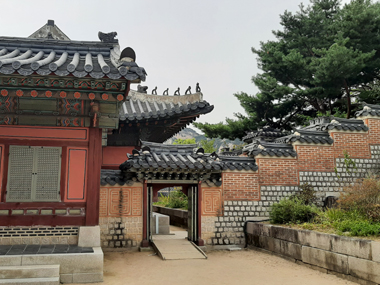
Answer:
[{"left": 0, "top": 37, "right": 146, "bottom": 81}]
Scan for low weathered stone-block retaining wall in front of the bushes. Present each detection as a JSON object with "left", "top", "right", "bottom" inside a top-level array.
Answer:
[{"left": 247, "top": 223, "right": 380, "bottom": 284}]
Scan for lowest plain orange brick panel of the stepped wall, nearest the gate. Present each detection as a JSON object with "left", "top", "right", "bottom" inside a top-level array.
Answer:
[{"left": 222, "top": 171, "right": 260, "bottom": 200}]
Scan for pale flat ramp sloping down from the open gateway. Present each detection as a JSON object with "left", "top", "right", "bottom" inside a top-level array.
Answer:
[{"left": 153, "top": 239, "right": 207, "bottom": 260}]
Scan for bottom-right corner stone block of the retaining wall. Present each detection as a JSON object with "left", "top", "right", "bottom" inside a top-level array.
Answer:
[{"left": 348, "top": 256, "right": 380, "bottom": 284}]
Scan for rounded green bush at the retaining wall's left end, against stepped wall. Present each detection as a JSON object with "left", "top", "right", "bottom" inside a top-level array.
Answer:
[{"left": 270, "top": 197, "right": 319, "bottom": 224}]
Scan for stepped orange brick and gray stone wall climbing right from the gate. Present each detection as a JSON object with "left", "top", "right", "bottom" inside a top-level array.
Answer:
[{"left": 202, "top": 119, "right": 380, "bottom": 245}]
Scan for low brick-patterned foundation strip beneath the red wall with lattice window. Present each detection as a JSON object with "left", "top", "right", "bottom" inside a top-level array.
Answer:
[{"left": 0, "top": 226, "right": 79, "bottom": 245}]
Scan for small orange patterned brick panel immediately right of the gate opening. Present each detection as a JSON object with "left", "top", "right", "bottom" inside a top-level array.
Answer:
[{"left": 202, "top": 187, "right": 223, "bottom": 216}]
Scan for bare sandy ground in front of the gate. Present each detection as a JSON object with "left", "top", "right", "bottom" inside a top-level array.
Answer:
[{"left": 78, "top": 247, "right": 355, "bottom": 285}]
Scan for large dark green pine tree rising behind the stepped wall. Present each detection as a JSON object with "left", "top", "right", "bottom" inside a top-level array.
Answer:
[{"left": 195, "top": 0, "right": 380, "bottom": 139}]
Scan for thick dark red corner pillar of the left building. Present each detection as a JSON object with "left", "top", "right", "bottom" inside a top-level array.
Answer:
[{"left": 86, "top": 128, "right": 102, "bottom": 226}]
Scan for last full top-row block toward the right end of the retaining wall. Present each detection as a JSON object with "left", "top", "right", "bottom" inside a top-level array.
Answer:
[{"left": 330, "top": 235, "right": 372, "bottom": 259}]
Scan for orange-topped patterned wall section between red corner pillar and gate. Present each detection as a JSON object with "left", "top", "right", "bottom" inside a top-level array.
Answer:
[{"left": 99, "top": 183, "right": 143, "bottom": 248}]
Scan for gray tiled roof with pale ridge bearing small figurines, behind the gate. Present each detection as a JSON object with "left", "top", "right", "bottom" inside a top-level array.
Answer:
[{"left": 119, "top": 90, "right": 214, "bottom": 121}]
